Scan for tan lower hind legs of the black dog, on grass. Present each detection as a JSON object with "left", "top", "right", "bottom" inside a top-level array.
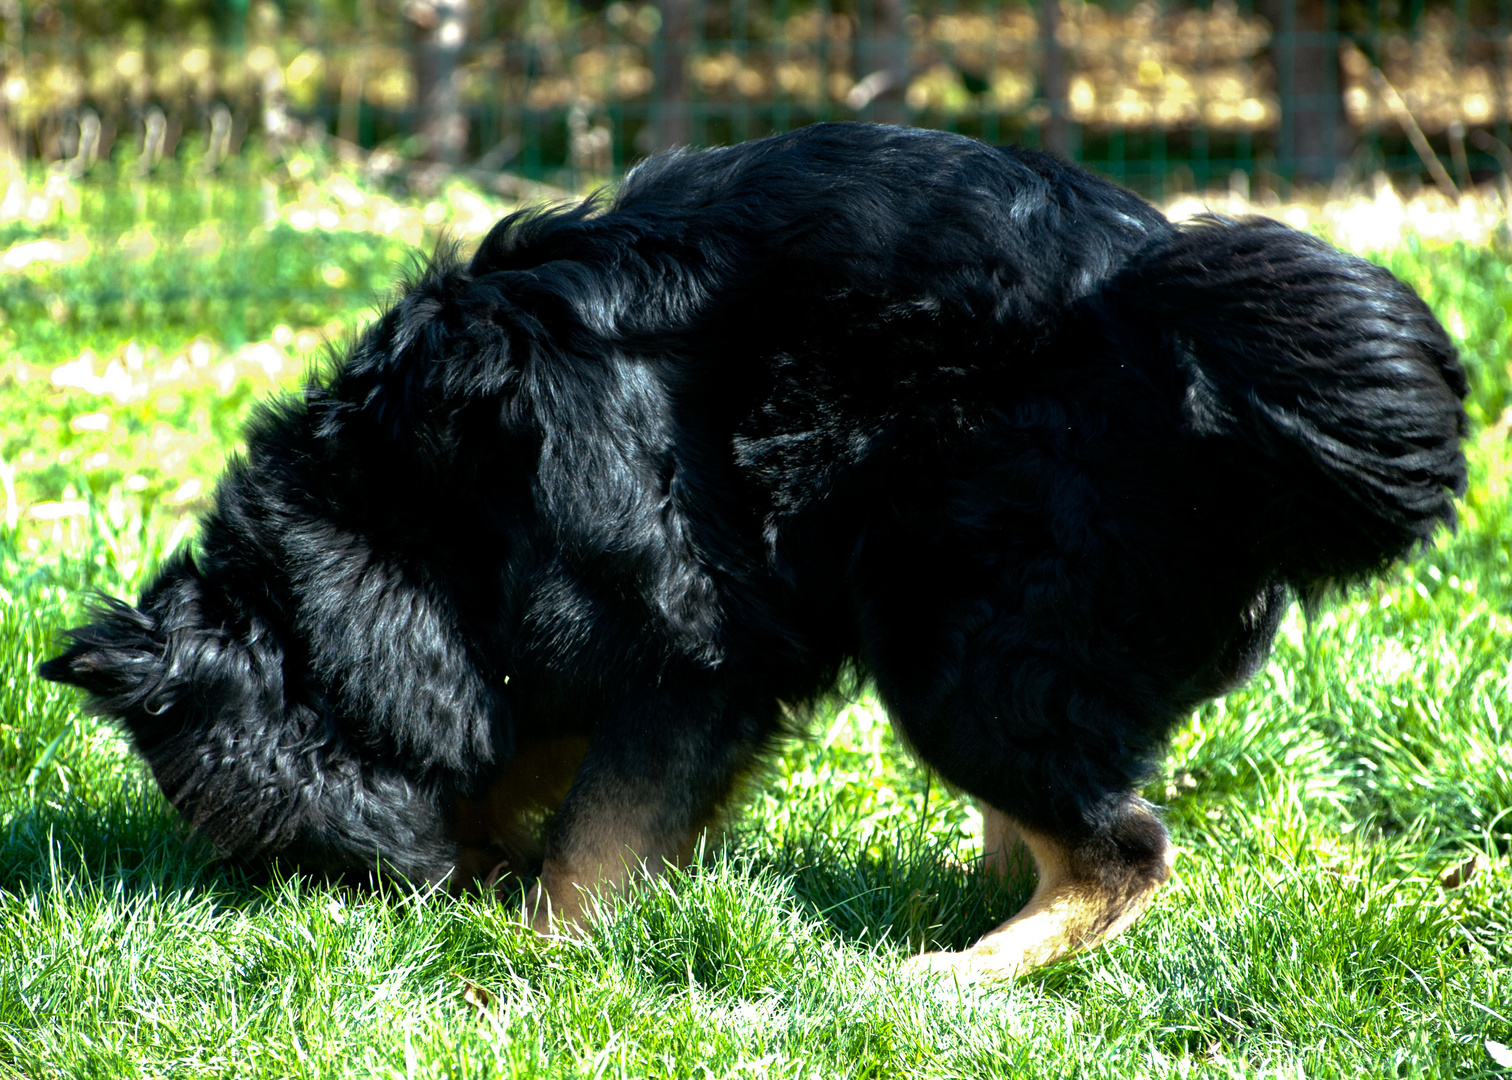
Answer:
[{"left": 910, "top": 794, "right": 1172, "bottom": 982}]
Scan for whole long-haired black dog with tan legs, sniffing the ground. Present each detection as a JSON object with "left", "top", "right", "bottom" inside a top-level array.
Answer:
[{"left": 42, "top": 124, "right": 1465, "bottom": 974}]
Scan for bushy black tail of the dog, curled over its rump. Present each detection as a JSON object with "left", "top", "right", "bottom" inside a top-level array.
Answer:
[{"left": 1105, "top": 218, "right": 1467, "bottom": 593}]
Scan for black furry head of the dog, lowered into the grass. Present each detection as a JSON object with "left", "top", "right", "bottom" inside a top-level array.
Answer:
[{"left": 39, "top": 554, "right": 455, "bottom": 882}]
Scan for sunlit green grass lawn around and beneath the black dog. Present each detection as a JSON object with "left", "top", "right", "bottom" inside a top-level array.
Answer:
[{"left": 0, "top": 153, "right": 1512, "bottom": 1077}]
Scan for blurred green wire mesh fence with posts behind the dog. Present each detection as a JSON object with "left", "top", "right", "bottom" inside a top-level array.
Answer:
[{"left": 0, "top": 0, "right": 1512, "bottom": 195}]
